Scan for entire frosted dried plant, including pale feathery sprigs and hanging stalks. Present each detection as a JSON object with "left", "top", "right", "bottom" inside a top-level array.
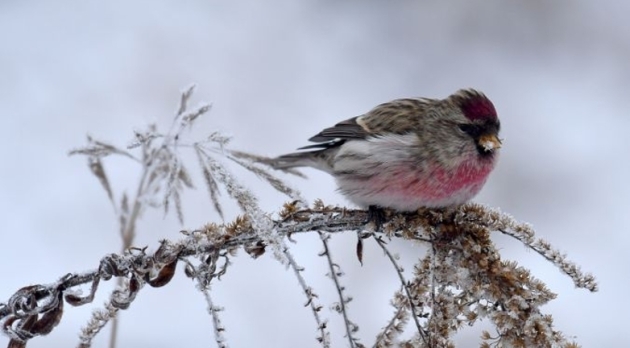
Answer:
[{"left": 0, "top": 88, "right": 597, "bottom": 348}]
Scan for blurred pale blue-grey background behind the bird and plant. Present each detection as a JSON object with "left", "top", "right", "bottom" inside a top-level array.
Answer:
[{"left": 0, "top": 0, "right": 630, "bottom": 347}]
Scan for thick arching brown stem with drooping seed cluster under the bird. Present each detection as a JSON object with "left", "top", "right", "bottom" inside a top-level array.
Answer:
[{"left": 0, "top": 201, "right": 596, "bottom": 347}]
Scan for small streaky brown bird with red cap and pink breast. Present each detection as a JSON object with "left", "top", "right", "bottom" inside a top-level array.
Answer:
[{"left": 268, "top": 89, "right": 501, "bottom": 211}]
